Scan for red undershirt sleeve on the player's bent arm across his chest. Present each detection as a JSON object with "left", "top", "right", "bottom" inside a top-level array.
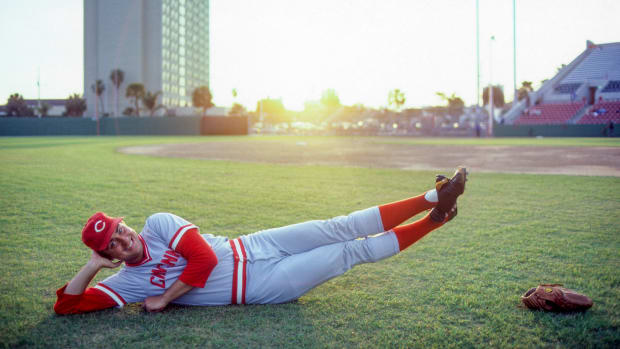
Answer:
[{"left": 175, "top": 228, "right": 217, "bottom": 288}]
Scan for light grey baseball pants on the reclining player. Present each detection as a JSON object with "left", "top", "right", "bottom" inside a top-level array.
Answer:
[{"left": 241, "top": 207, "right": 400, "bottom": 304}]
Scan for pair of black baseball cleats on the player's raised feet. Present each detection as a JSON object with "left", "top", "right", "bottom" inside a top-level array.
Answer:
[{"left": 431, "top": 166, "right": 467, "bottom": 222}]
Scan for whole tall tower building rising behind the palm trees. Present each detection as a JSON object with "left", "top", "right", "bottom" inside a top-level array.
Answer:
[{"left": 84, "top": 0, "right": 209, "bottom": 117}]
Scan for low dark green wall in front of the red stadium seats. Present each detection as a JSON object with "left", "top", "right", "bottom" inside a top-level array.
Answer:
[{"left": 493, "top": 124, "right": 620, "bottom": 137}]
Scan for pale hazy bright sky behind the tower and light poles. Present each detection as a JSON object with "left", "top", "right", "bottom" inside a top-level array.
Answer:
[{"left": 0, "top": 0, "right": 620, "bottom": 110}]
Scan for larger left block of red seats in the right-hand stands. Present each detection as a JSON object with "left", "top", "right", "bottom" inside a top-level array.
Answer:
[{"left": 515, "top": 102, "right": 585, "bottom": 125}]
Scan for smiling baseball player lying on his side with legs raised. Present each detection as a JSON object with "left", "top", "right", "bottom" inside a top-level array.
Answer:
[{"left": 54, "top": 167, "right": 467, "bottom": 314}]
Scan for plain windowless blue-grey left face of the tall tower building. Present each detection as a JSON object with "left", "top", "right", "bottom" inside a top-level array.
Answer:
[{"left": 84, "top": 0, "right": 161, "bottom": 117}]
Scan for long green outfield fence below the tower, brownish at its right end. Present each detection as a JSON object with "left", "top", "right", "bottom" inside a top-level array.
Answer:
[{"left": 0, "top": 116, "right": 248, "bottom": 136}]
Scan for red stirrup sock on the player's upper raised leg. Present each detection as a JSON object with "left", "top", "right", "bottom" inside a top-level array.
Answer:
[{"left": 379, "top": 189, "right": 437, "bottom": 231}]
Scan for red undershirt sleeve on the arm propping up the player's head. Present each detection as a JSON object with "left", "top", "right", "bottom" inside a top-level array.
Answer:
[{"left": 54, "top": 284, "right": 118, "bottom": 315}]
